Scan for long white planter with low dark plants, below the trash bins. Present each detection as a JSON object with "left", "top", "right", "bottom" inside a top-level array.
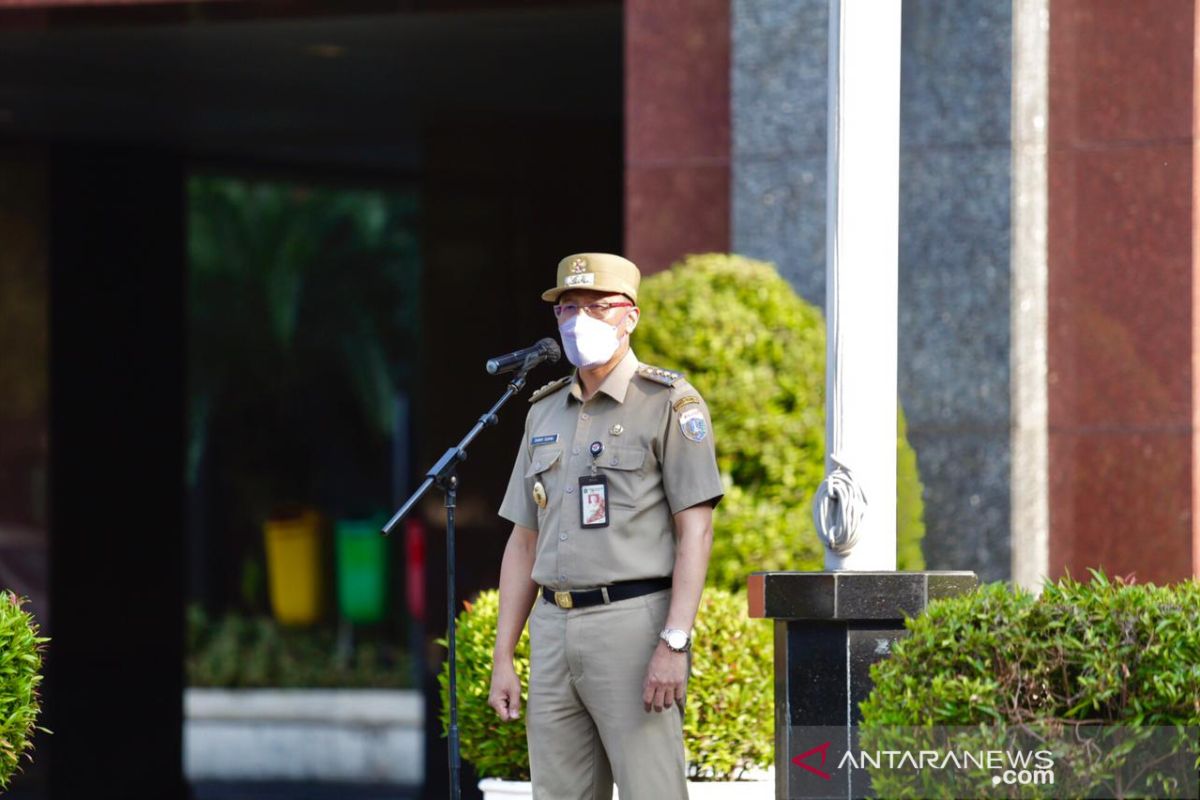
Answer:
[{"left": 184, "top": 603, "right": 425, "bottom": 783}]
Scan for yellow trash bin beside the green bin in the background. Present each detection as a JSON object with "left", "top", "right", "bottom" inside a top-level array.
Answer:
[{"left": 263, "top": 509, "right": 320, "bottom": 625}]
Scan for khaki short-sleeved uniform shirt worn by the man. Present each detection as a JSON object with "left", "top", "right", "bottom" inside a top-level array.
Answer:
[{"left": 500, "top": 350, "right": 725, "bottom": 589}]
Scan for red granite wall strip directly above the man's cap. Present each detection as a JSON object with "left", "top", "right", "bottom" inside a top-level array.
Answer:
[{"left": 625, "top": 0, "right": 730, "bottom": 272}]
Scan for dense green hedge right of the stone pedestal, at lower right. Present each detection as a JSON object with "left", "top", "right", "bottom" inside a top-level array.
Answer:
[{"left": 860, "top": 572, "right": 1200, "bottom": 798}]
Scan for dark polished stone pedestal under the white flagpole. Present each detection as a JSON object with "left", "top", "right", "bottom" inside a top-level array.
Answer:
[{"left": 748, "top": 572, "right": 978, "bottom": 800}]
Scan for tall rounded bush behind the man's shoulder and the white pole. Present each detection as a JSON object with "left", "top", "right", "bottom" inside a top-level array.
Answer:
[{"left": 634, "top": 253, "right": 925, "bottom": 589}]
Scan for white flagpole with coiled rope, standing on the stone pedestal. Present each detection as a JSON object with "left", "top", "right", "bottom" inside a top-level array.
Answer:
[{"left": 812, "top": 0, "right": 902, "bottom": 571}]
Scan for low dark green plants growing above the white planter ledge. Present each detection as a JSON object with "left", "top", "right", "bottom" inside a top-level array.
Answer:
[{"left": 187, "top": 606, "right": 413, "bottom": 688}]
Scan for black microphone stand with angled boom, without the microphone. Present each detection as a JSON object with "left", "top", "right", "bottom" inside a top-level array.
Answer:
[{"left": 380, "top": 357, "right": 541, "bottom": 800}]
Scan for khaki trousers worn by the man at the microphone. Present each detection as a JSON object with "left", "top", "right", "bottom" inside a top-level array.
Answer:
[{"left": 526, "top": 589, "right": 691, "bottom": 800}]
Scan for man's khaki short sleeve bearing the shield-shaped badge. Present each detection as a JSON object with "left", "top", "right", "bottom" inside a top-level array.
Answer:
[{"left": 662, "top": 384, "right": 725, "bottom": 513}]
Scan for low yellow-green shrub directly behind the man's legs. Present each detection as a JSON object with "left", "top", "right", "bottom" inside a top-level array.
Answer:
[{"left": 439, "top": 588, "right": 774, "bottom": 781}]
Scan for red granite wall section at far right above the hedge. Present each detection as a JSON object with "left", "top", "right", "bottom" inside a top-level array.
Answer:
[{"left": 1048, "top": 0, "right": 1198, "bottom": 582}]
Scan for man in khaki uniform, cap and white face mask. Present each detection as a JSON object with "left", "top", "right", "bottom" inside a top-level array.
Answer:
[{"left": 488, "top": 253, "right": 724, "bottom": 800}]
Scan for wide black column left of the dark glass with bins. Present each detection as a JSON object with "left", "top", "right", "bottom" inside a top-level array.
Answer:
[{"left": 48, "top": 145, "right": 186, "bottom": 800}]
